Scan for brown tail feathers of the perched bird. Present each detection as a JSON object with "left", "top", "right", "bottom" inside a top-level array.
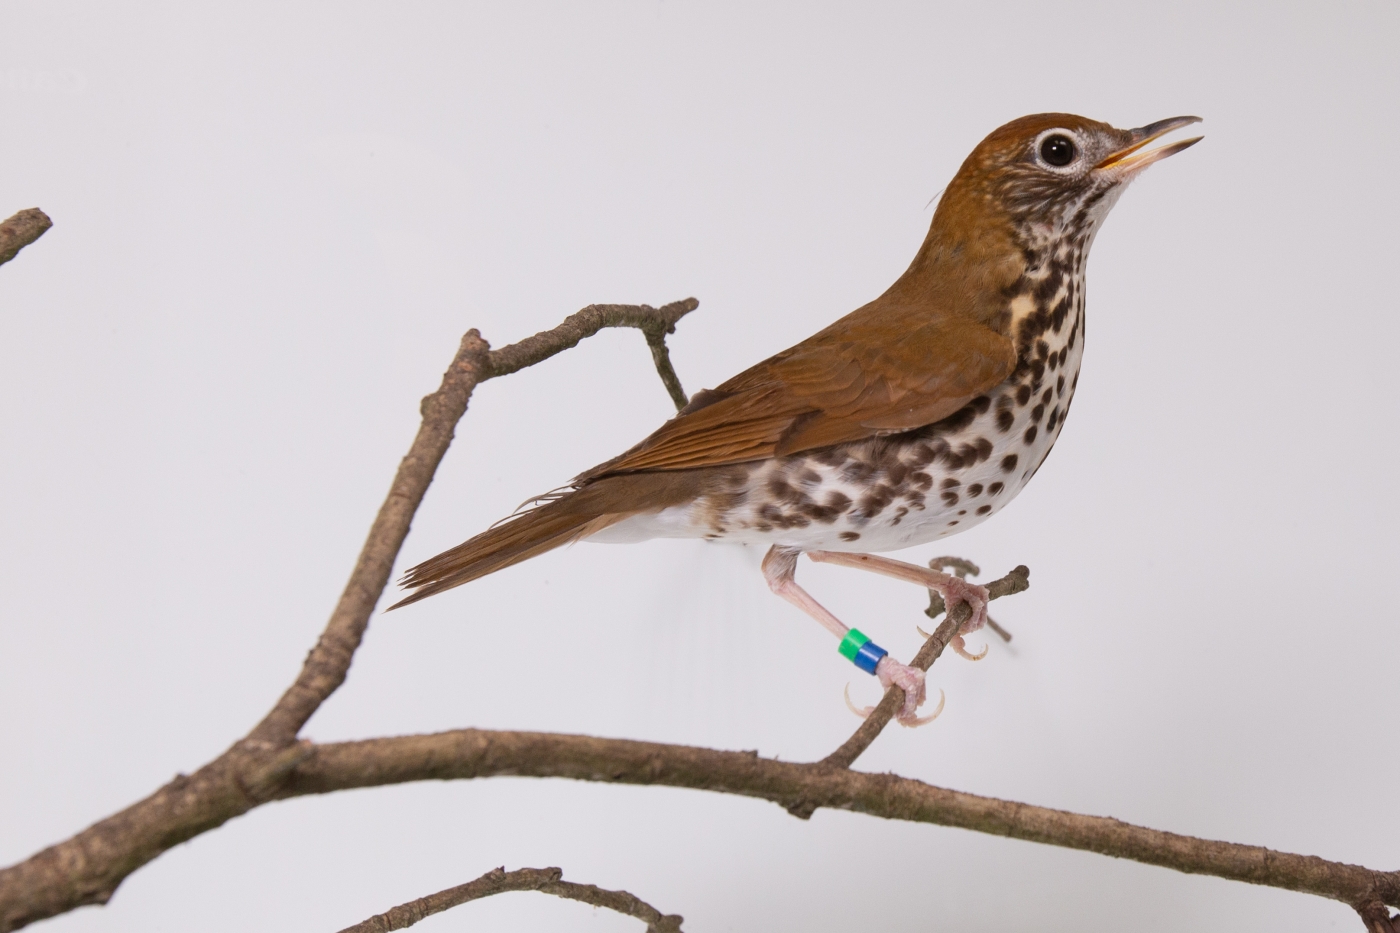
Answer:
[{"left": 389, "top": 471, "right": 699, "bottom": 609}]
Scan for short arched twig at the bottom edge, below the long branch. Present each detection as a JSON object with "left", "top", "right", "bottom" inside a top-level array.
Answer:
[{"left": 340, "top": 867, "right": 685, "bottom": 933}]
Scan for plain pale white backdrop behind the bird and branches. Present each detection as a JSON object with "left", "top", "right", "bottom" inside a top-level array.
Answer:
[{"left": 0, "top": 0, "right": 1400, "bottom": 933}]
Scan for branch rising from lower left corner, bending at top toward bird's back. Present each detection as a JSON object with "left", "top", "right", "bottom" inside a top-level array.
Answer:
[{"left": 0, "top": 301, "right": 699, "bottom": 933}]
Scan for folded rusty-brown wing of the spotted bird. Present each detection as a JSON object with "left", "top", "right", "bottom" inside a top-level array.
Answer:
[{"left": 578, "top": 305, "right": 1016, "bottom": 481}]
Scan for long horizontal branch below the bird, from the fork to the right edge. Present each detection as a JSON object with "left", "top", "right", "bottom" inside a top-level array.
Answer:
[{"left": 281, "top": 728, "right": 1400, "bottom": 913}]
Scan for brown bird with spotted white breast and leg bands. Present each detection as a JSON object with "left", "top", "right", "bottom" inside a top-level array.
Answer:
[{"left": 391, "top": 113, "right": 1203, "bottom": 726}]
